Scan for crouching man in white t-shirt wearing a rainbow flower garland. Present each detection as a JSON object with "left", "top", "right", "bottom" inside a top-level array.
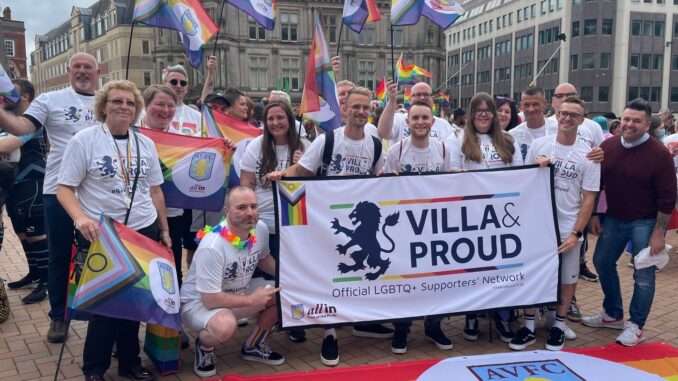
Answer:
[{"left": 181, "top": 186, "right": 285, "bottom": 377}]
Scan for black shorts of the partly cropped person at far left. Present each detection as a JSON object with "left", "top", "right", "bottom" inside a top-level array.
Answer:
[{"left": 6, "top": 179, "right": 45, "bottom": 237}]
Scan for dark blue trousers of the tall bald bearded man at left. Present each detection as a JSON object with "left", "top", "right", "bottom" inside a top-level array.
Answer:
[{"left": 43, "top": 194, "right": 75, "bottom": 320}]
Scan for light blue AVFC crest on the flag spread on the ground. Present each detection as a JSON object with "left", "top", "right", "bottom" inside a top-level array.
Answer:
[{"left": 467, "top": 359, "right": 585, "bottom": 381}]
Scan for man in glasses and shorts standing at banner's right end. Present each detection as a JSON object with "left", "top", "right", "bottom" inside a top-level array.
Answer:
[{"left": 509, "top": 97, "right": 600, "bottom": 351}]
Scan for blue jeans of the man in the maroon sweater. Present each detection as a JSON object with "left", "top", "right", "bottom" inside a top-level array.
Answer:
[{"left": 593, "top": 215, "right": 656, "bottom": 328}]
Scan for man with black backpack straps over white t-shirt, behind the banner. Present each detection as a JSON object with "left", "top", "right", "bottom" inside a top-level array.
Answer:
[{"left": 269, "top": 87, "right": 393, "bottom": 366}]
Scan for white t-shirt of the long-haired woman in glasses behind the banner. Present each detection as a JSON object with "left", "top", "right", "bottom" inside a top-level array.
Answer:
[{"left": 450, "top": 134, "right": 523, "bottom": 170}]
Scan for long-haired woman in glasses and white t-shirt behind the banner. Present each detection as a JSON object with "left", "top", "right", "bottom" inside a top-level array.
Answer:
[{"left": 450, "top": 93, "right": 523, "bottom": 342}]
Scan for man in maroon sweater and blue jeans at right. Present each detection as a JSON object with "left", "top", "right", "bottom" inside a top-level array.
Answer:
[{"left": 582, "top": 99, "right": 676, "bottom": 346}]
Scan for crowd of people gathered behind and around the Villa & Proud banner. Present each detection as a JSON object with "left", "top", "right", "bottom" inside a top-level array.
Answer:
[{"left": 0, "top": 53, "right": 678, "bottom": 381}]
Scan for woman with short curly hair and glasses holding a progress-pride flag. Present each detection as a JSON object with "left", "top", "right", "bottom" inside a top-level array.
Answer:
[{"left": 57, "top": 81, "right": 172, "bottom": 380}]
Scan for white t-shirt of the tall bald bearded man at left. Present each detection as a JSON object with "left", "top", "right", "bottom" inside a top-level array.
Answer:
[{"left": 24, "top": 87, "right": 99, "bottom": 193}]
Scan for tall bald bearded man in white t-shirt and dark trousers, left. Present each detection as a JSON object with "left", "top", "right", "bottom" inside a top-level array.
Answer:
[{"left": 0, "top": 53, "right": 100, "bottom": 343}]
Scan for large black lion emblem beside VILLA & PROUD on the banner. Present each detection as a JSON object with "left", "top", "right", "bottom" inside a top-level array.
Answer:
[{"left": 332, "top": 201, "right": 400, "bottom": 280}]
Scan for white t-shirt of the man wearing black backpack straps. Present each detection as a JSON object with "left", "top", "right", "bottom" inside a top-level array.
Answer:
[{"left": 299, "top": 127, "right": 384, "bottom": 176}]
